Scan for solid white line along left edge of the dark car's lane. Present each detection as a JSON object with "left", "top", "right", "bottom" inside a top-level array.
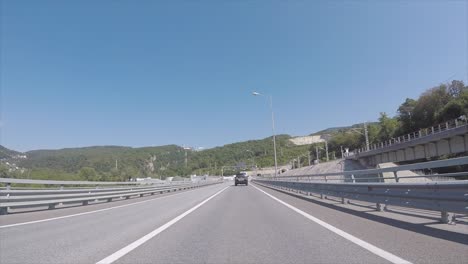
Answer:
[{"left": 96, "top": 186, "right": 230, "bottom": 264}]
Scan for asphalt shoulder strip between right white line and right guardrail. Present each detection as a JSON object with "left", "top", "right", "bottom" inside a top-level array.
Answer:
[{"left": 252, "top": 185, "right": 468, "bottom": 263}]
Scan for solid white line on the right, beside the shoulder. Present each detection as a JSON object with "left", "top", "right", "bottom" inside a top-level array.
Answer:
[{"left": 252, "top": 185, "right": 411, "bottom": 264}]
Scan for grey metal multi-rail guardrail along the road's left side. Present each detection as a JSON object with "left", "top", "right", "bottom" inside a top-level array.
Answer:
[{"left": 0, "top": 178, "right": 223, "bottom": 214}]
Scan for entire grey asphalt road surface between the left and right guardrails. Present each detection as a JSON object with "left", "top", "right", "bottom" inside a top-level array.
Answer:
[{"left": 0, "top": 182, "right": 468, "bottom": 264}]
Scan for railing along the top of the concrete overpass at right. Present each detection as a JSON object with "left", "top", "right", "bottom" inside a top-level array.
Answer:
[{"left": 351, "top": 117, "right": 468, "bottom": 156}]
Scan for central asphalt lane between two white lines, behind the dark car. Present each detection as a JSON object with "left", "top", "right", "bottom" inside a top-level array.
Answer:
[{"left": 112, "top": 186, "right": 402, "bottom": 263}]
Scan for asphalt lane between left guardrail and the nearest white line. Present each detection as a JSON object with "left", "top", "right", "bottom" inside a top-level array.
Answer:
[{"left": 0, "top": 184, "right": 226, "bottom": 264}]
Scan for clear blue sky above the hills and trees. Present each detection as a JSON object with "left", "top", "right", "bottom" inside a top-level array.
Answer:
[{"left": 0, "top": 0, "right": 468, "bottom": 151}]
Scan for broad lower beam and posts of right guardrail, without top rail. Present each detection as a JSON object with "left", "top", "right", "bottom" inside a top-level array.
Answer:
[{"left": 254, "top": 179, "right": 468, "bottom": 223}]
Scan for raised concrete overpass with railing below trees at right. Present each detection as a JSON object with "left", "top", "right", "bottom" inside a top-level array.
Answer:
[{"left": 347, "top": 120, "right": 468, "bottom": 166}]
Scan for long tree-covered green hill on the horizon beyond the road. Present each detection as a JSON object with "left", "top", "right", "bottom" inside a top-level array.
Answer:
[{"left": 0, "top": 135, "right": 310, "bottom": 180}]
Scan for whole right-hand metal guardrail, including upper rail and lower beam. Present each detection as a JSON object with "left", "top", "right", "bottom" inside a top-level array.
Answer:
[{"left": 254, "top": 157, "right": 468, "bottom": 223}]
